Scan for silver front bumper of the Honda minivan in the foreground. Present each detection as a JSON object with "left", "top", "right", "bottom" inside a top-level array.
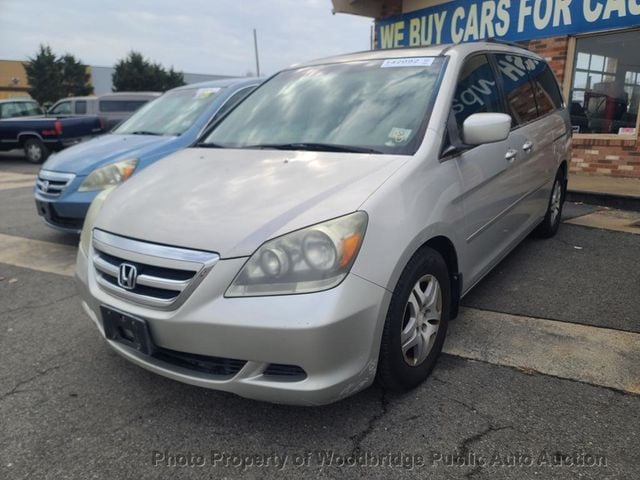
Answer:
[{"left": 76, "top": 244, "right": 391, "bottom": 405}]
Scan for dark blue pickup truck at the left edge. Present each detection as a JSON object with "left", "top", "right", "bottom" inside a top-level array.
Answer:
[{"left": 0, "top": 99, "right": 103, "bottom": 163}]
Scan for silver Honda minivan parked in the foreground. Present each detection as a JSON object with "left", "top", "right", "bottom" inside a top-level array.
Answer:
[{"left": 77, "top": 43, "right": 571, "bottom": 405}]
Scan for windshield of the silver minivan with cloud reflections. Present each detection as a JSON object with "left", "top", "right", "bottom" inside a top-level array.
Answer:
[{"left": 204, "top": 57, "right": 444, "bottom": 154}]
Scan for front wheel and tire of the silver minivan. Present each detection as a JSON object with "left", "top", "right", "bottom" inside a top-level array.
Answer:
[{"left": 378, "top": 247, "right": 451, "bottom": 392}]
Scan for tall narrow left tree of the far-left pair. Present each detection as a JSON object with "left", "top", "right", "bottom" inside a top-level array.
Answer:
[{"left": 24, "top": 45, "right": 62, "bottom": 104}]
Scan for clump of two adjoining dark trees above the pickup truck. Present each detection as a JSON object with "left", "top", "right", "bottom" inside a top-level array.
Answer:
[{"left": 24, "top": 45, "right": 93, "bottom": 104}]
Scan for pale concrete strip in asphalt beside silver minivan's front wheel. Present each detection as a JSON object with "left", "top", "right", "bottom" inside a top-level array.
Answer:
[{"left": 443, "top": 308, "right": 640, "bottom": 395}]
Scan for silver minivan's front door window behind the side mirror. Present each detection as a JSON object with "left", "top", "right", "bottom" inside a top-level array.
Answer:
[{"left": 452, "top": 55, "right": 504, "bottom": 131}]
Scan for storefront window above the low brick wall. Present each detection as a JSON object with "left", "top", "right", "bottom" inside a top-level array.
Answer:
[{"left": 570, "top": 31, "right": 640, "bottom": 135}]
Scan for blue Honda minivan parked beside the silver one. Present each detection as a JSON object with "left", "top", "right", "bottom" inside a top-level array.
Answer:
[{"left": 34, "top": 78, "right": 261, "bottom": 232}]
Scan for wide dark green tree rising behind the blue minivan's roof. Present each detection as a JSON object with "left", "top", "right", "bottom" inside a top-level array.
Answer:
[{"left": 112, "top": 51, "right": 185, "bottom": 92}]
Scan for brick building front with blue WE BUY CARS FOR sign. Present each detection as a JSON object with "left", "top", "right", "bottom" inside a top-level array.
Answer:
[{"left": 333, "top": 0, "right": 640, "bottom": 178}]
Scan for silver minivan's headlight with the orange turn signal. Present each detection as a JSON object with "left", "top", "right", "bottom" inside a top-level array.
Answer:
[{"left": 225, "top": 212, "right": 368, "bottom": 297}]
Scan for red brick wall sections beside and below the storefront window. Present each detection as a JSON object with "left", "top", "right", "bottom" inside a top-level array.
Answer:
[{"left": 527, "top": 36, "right": 640, "bottom": 178}]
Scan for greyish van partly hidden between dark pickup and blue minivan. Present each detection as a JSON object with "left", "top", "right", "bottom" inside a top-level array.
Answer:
[{"left": 47, "top": 92, "right": 161, "bottom": 131}]
